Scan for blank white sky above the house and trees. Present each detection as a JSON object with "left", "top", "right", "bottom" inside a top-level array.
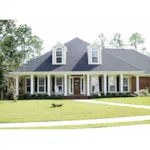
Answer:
[{"left": 0, "top": 0, "right": 150, "bottom": 53}]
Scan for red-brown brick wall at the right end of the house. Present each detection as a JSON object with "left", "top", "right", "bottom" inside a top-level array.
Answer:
[{"left": 131, "top": 77, "right": 150, "bottom": 93}]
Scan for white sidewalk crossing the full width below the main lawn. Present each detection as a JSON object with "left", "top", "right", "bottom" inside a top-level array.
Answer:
[{"left": 0, "top": 115, "right": 150, "bottom": 128}]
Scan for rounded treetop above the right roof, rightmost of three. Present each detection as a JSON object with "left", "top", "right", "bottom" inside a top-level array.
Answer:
[{"left": 129, "top": 32, "right": 145, "bottom": 50}]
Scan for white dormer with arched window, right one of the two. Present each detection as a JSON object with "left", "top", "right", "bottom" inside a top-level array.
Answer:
[{"left": 87, "top": 42, "right": 102, "bottom": 65}]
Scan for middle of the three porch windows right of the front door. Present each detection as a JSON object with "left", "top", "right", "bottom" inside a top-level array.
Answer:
[{"left": 108, "top": 76, "right": 116, "bottom": 92}]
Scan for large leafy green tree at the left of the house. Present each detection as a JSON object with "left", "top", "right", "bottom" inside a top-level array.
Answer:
[{"left": 0, "top": 20, "right": 43, "bottom": 99}]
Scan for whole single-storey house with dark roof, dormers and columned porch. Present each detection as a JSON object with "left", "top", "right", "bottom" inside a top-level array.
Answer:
[{"left": 10, "top": 38, "right": 150, "bottom": 96}]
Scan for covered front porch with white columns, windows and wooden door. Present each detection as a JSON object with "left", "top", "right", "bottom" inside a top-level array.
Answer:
[{"left": 15, "top": 72, "right": 139, "bottom": 96}]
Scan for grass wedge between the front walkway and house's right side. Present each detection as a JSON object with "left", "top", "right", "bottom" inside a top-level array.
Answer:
[{"left": 95, "top": 97, "right": 150, "bottom": 106}]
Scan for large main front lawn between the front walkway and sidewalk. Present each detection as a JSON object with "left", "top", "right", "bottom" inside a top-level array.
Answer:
[{"left": 0, "top": 100, "right": 150, "bottom": 123}]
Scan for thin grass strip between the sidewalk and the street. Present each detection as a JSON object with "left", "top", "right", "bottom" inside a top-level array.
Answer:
[{"left": 3, "top": 120, "right": 150, "bottom": 129}]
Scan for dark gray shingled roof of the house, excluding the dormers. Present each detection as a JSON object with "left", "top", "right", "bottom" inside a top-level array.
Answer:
[{"left": 16, "top": 38, "right": 150, "bottom": 72}]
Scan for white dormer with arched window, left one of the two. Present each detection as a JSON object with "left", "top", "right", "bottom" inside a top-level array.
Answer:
[{"left": 52, "top": 43, "right": 67, "bottom": 65}]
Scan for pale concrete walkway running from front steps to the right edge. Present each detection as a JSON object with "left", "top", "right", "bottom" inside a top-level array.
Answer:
[{"left": 74, "top": 99, "right": 150, "bottom": 109}]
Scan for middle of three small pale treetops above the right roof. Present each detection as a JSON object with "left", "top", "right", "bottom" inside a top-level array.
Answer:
[{"left": 109, "top": 33, "right": 124, "bottom": 48}]
